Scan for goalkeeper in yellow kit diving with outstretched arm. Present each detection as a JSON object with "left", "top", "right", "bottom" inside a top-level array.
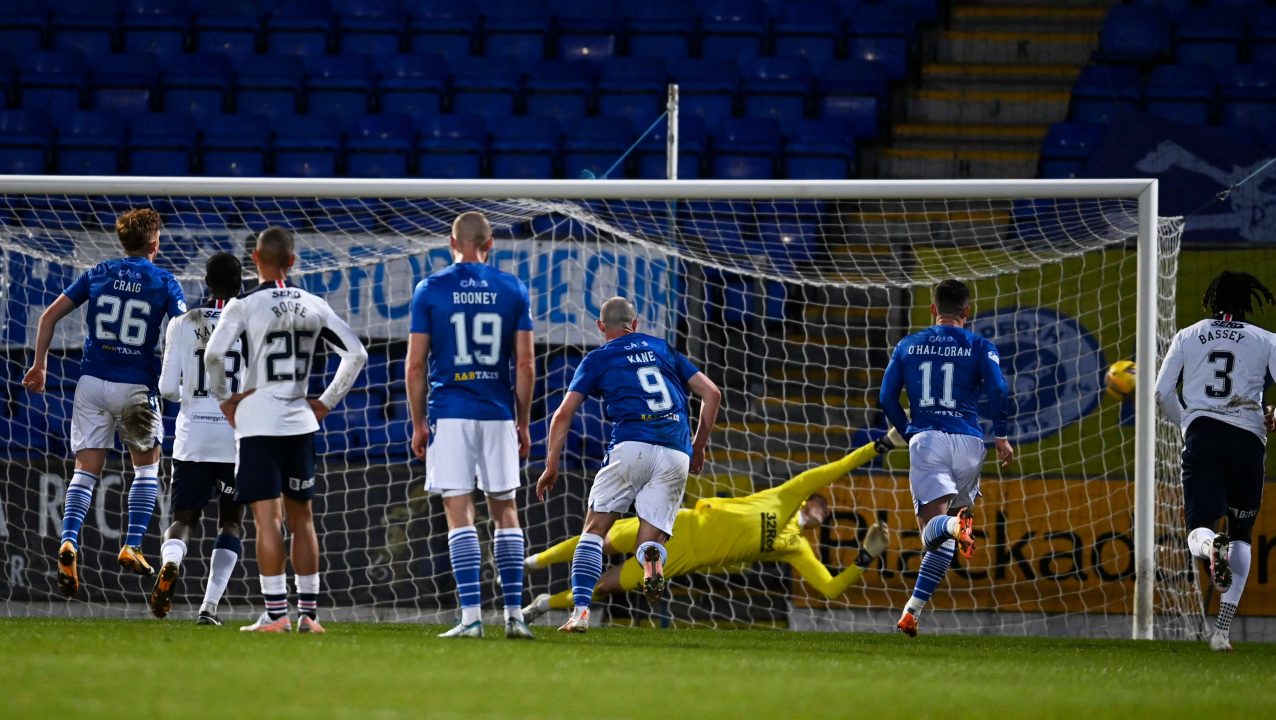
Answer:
[{"left": 523, "top": 429, "right": 903, "bottom": 622}]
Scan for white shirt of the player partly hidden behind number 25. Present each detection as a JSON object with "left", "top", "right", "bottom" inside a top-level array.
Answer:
[{"left": 160, "top": 300, "right": 242, "bottom": 463}]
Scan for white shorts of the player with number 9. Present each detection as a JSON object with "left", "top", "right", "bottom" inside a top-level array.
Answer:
[{"left": 590, "top": 440, "right": 692, "bottom": 535}]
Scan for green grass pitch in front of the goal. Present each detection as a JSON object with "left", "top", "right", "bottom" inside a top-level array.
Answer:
[{"left": 0, "top": 619, "right": 1276, "bottom": 720}]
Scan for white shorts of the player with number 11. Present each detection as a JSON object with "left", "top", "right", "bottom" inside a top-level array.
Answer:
[{"left": 909, "top": 430, "right": 988, "bottom": 509}]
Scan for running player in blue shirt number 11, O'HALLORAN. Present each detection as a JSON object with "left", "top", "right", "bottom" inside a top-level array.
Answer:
[{"left": 879, "top": 280, "right": 1014, "bottom": 637}]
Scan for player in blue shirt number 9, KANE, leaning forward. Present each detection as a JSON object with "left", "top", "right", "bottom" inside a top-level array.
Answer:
[{"left": 536, "top": 297, "right": 722, "bottom": 632}]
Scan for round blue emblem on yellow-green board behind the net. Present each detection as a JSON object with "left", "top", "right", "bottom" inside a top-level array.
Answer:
[{"left": 970, "top": 308, "right": 1108, "bottom": 443}]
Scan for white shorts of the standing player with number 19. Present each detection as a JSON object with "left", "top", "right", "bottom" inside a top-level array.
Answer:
[{"left": 425, "top": 417, "right": 523, "bottom": 495}]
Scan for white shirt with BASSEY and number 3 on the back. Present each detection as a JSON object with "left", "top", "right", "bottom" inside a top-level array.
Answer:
[{"left": 1156, "top": 315, "right": 1276, "bottom": 443}]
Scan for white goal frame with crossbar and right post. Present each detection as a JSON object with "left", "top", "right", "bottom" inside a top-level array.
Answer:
[{"left": 0, "top": 175, "right": 1160, "bottom": 640}]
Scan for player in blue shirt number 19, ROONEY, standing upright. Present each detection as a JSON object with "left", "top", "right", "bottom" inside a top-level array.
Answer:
[{"left": 407, "top": 212, "right": 535, "bottom": 638}]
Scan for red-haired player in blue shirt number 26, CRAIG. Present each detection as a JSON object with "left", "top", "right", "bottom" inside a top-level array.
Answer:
[{"left": 23, "top": 208, "right": 186, "bottom": 597}]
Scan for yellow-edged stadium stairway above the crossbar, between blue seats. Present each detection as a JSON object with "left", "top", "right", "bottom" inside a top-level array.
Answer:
[{"left": 879, "top": 0, "right": 1113, "bottom": 179}]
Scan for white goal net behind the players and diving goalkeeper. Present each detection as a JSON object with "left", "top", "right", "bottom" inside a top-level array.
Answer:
[{"left": 0, "top": 179, "right": 1202, "bottom": 637}]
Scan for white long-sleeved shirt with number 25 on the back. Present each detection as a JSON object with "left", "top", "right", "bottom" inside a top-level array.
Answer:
[{"left": 204, "top": 281, "right": 367, "bottom": 438}]
